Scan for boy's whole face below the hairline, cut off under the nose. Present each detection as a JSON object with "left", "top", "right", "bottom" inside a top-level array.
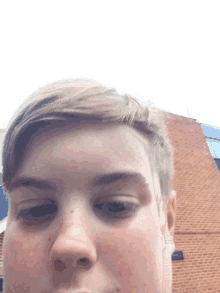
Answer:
[{"left": 3, "top": 125, "right": 175, "bottom": 293}]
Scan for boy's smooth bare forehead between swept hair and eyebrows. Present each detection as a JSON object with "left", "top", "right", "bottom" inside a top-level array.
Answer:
[{"left": 16, "top": 124, "right": 153, "bottom": 182}]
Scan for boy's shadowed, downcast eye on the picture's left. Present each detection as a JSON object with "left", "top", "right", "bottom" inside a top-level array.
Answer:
[{"left": 19, "top": 204, "right": 57, "bottom": 225}]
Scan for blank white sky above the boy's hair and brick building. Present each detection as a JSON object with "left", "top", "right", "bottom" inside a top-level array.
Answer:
[{"left": 0, "top": 0, "right": 220, "bottom": 129}]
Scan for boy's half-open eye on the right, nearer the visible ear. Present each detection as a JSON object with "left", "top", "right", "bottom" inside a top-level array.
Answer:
[{"left": 95, "top": 200, "right": 139, "bottom": 219}]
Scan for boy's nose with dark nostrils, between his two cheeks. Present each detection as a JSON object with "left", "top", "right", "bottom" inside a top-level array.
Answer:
[{"left": 50, "top": 211, "right": 97, "bottom": 272}]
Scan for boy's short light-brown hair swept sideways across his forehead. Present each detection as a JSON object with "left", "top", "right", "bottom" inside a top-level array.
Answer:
[{"left": 2, "top": 79, "right": 173, "bottom": 212}]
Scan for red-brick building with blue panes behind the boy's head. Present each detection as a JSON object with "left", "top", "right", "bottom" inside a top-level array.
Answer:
[{"left": 0, "top": 113, "right": 220, "bottom": 293}]
